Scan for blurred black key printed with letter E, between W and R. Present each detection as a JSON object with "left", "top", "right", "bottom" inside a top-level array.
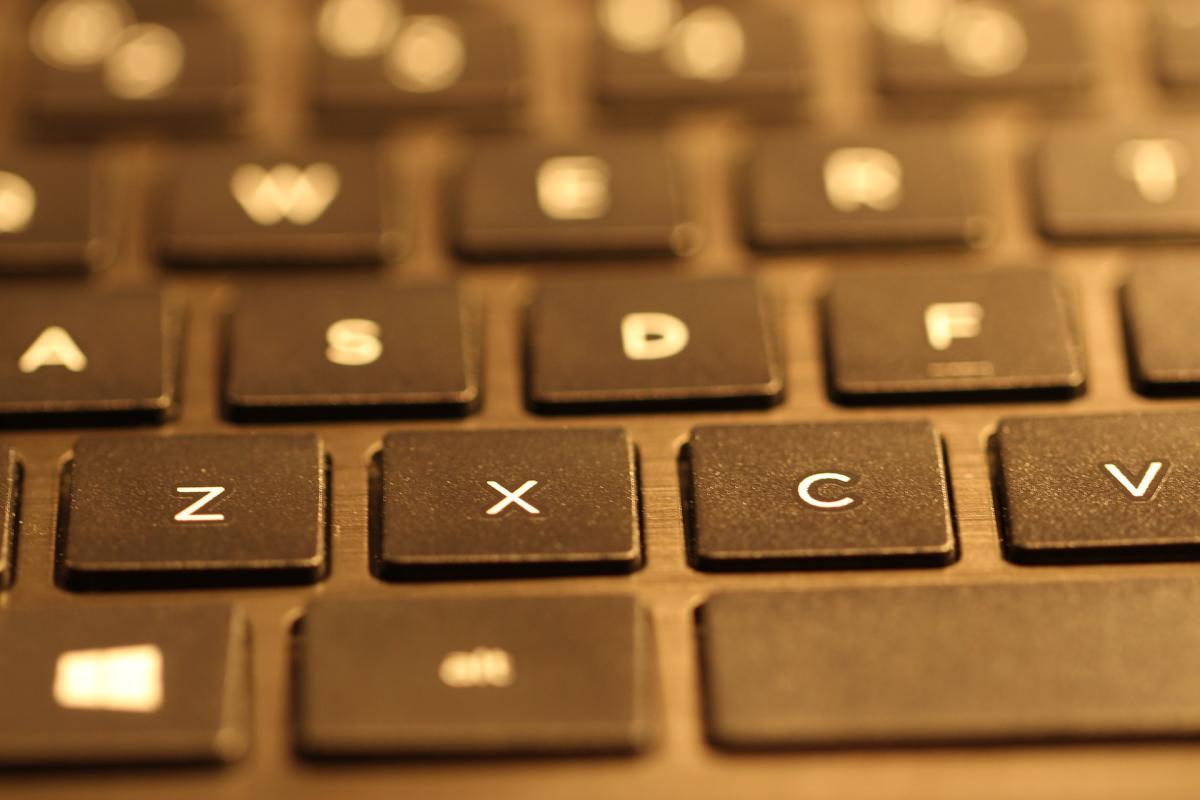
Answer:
[{"left": 454, "top": 134, "right": 698, "bottom": 259}]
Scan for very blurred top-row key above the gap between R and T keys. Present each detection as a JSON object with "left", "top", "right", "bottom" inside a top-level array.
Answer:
[{"left": 871, "top": 0, "right": 1093, "bottom": 94}]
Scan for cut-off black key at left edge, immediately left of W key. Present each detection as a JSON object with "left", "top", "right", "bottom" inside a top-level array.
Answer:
[{"left": 0, "top": 149, "right": 103, "bottom": 275}]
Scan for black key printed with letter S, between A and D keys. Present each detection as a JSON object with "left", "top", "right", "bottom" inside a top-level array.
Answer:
[{"left": 226, "top": 284, "right": 480, "bottom": 420}]
